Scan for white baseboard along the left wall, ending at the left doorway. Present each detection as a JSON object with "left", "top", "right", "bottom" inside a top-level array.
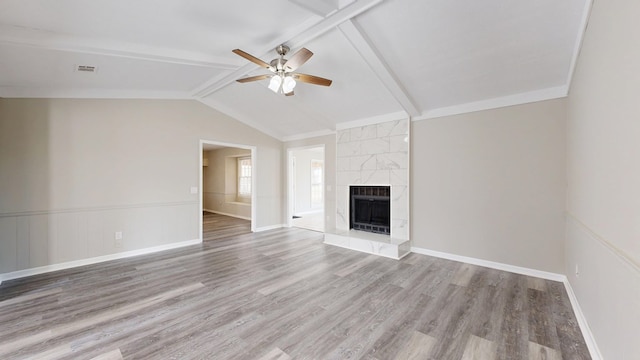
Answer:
[{"left": 0, "top": 239, "right": 202, "bottom": 283}]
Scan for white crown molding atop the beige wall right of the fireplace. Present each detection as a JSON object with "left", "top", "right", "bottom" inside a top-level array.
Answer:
[{"left": 413, "top": 85, "right": 568, "bottom": 121}]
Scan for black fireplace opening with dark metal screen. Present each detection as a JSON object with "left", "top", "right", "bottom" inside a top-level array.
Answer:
[{"left": 349, "top": 186, "right": 391, "bottom": 234}]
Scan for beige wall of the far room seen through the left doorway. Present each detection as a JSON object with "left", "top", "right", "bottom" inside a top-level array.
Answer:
[{"left": 202, "top": 147, "right": 251, "bottom": 220}]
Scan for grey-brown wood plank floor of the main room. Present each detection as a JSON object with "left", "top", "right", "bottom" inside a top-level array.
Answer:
[{"left": 0, "top": 222, "right": 590, "bottom": 360}]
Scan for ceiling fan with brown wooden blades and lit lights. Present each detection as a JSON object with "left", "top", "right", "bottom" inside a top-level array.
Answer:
[{"left": 233, "top": 44, "right": 331, "bottom": 96}]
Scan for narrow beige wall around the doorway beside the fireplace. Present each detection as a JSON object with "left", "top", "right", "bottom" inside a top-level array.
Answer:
[{"left": 282, "top": 134, "right": 337, "bottom": 231}]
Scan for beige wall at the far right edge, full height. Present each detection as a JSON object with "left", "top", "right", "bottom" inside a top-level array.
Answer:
[{"left": 566, "top": 0, "right": 640, "bottom": 359}]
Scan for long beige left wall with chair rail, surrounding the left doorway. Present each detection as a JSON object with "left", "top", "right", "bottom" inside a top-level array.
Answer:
[{"left": 0, "top": 99, "right": 282, "bottom": 274}]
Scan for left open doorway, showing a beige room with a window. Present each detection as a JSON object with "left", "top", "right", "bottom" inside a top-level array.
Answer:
[{"left": 200, "top": 140, "right": 256, "bottom": 241}]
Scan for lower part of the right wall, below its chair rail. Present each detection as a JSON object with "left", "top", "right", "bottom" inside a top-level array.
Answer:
[{"left": 566, "top": 214, "right": 640, "bottom": 360}]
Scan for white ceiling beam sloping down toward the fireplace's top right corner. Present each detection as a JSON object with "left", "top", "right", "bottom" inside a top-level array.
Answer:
[{"left": 338, "top": 21, "right": 421, "bottom": 117}]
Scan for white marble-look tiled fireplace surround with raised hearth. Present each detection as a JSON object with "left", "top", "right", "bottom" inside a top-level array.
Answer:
[{"left": 325, "top": 120, "right": 410, "bottom": 259}]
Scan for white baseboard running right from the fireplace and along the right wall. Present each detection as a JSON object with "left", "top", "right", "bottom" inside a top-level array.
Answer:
[{"left": 411, "top": 247, "right": 602, "bottom": 360}]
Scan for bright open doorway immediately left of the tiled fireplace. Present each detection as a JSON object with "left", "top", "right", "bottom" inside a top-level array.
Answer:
[{"left": 287, "top": 146, "right": 325, "bottom": 232}]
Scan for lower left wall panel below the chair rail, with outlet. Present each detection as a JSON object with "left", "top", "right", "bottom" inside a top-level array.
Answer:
[{"left": 0, "top": 202, "right": 200, "bottom": 281}]
